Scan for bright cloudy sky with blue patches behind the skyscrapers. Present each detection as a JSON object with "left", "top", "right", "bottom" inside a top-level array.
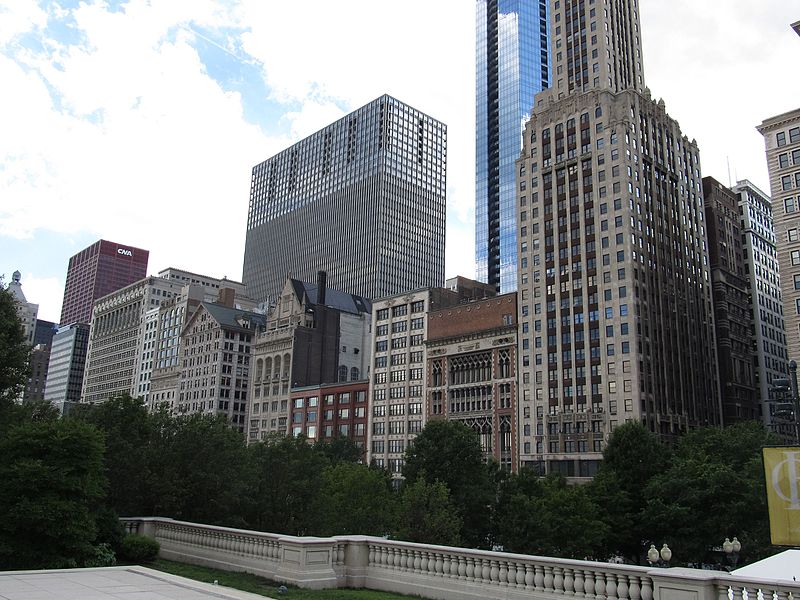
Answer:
[{"left": 0, "top": 0, "right": 800, "bottom": 322}]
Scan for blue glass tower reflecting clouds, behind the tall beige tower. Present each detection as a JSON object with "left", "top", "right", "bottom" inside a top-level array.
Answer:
[{"left": 475, "top": 0, "right": 550, "bottom": 293}]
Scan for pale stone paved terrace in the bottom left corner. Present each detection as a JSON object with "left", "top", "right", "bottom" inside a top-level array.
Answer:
[{"left": 0, "top": 567, "right": 272, "bottom": 600}]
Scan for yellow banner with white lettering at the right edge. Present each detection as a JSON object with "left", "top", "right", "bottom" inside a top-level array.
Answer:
[{"left": 763, "top": 446, "right": 800, "bottom": 546}]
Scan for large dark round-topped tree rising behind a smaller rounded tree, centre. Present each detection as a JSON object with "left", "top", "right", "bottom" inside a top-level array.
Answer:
[{"left": 403, "top": 419, "right": 494, "bottom": 547}]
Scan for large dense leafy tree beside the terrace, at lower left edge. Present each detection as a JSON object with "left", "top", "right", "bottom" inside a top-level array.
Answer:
[{"left": 0, "top": 419, "right": 105, "bottom": 569}]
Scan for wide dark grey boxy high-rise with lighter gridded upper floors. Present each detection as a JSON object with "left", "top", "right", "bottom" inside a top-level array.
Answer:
[{"left": 242, "top": 96, "right": 447, "bottom": 303}]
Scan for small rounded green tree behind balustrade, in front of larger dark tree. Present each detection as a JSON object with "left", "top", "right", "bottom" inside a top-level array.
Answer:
[{"left": 395, "top": 478, "right": 462, "bottom": 546}]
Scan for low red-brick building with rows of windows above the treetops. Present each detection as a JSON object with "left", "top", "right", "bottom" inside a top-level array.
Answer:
[{"left": 289, "top": 379, "right": 369, "bottom": 460}]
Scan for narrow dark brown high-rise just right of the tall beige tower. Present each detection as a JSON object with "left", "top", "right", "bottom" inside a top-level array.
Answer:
[{"left": 703, "top": 177, "right": 760, "bottom": 425}]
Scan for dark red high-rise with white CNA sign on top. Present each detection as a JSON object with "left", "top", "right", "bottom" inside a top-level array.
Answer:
[{"left": 61, "top": 240, "right": 150, "bottom": 325}]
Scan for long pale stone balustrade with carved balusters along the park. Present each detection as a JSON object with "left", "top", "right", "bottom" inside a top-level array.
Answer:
[{"left": 122, "top": 517, "right": 800, "bottom": 600}]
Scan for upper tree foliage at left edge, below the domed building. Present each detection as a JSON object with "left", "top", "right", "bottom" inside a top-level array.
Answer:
[{"left": 0, "top": 280, "right": 30, "bottom": 408}]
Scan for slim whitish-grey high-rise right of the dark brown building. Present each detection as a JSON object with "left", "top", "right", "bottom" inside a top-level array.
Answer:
[{"left": 732, "top": 179, "right": 794, "bottom": 439}]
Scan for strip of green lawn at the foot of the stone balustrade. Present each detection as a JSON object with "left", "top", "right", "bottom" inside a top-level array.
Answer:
[{"left": 145, "top": 558, "right": 418, "bottom": 600}]
